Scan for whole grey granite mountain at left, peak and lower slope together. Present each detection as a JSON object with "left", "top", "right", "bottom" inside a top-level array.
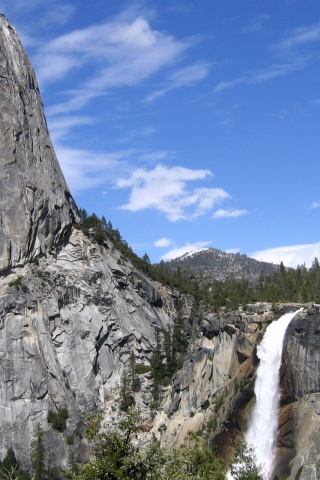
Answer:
[{"left": 0, "top": 15, "right": 174, "bottom": 467}]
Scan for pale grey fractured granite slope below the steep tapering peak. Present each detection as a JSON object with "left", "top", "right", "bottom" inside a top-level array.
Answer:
[{"left": 0, "top": 230, "right": 171, "bottom": 467}]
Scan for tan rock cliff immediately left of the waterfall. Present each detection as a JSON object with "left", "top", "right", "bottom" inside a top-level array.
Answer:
[{"left": 155, "top": 304, "right": 274, "bottom": 445}]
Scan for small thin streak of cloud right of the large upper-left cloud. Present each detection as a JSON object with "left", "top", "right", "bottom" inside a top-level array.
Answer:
[{"left": 145, "top": 62, "right": 210, "bottom": 103}]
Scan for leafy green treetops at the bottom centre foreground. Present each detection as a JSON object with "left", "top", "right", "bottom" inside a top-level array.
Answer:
[{"left": 66, "top": 409, "right": 225, "bottom": 480}]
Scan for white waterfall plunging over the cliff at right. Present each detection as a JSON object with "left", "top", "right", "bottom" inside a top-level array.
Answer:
[{"left": 227, "top": 308, "right": 302, "bottom": 480}]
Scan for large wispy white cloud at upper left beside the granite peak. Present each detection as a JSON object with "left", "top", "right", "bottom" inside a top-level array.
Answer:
[{"left": 35, "top": 16, "right": 194, "bottom": 114}]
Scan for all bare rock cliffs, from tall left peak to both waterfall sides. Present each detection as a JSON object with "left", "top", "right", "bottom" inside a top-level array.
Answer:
[{"left": 0, "top": 16, "right": 320, "bottom": 480}]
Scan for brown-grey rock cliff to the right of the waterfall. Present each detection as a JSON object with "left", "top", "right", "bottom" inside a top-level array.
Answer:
[{"left": 277, "top": 305, "right": 320, "bottom": 480}]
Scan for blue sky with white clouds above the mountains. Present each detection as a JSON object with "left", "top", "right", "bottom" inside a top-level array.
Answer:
[{"left": 0, "top": 0, "right": 320, "bottom": 266}]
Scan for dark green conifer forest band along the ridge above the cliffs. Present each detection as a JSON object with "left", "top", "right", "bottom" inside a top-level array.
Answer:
[{"left": 80, "top": 209, "right": 320, "bottom": 310}]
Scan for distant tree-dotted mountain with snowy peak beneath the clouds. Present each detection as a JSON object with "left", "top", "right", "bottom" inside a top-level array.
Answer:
[{"left": 166, "top": 248, "right": 279, "bottom": 282}]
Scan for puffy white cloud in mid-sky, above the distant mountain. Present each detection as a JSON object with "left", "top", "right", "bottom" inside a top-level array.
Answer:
[{"left": 116, "top": 164, "right": 230, "bottom": 222}]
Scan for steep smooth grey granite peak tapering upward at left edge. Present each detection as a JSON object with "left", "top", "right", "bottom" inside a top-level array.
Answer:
[{"left": 0, "top": 15, "right": 77, "bottom": 272}]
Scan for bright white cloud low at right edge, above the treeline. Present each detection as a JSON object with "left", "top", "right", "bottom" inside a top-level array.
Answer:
[{"left": 249, "top": 242, "right": 320, "bottom": 267}]
